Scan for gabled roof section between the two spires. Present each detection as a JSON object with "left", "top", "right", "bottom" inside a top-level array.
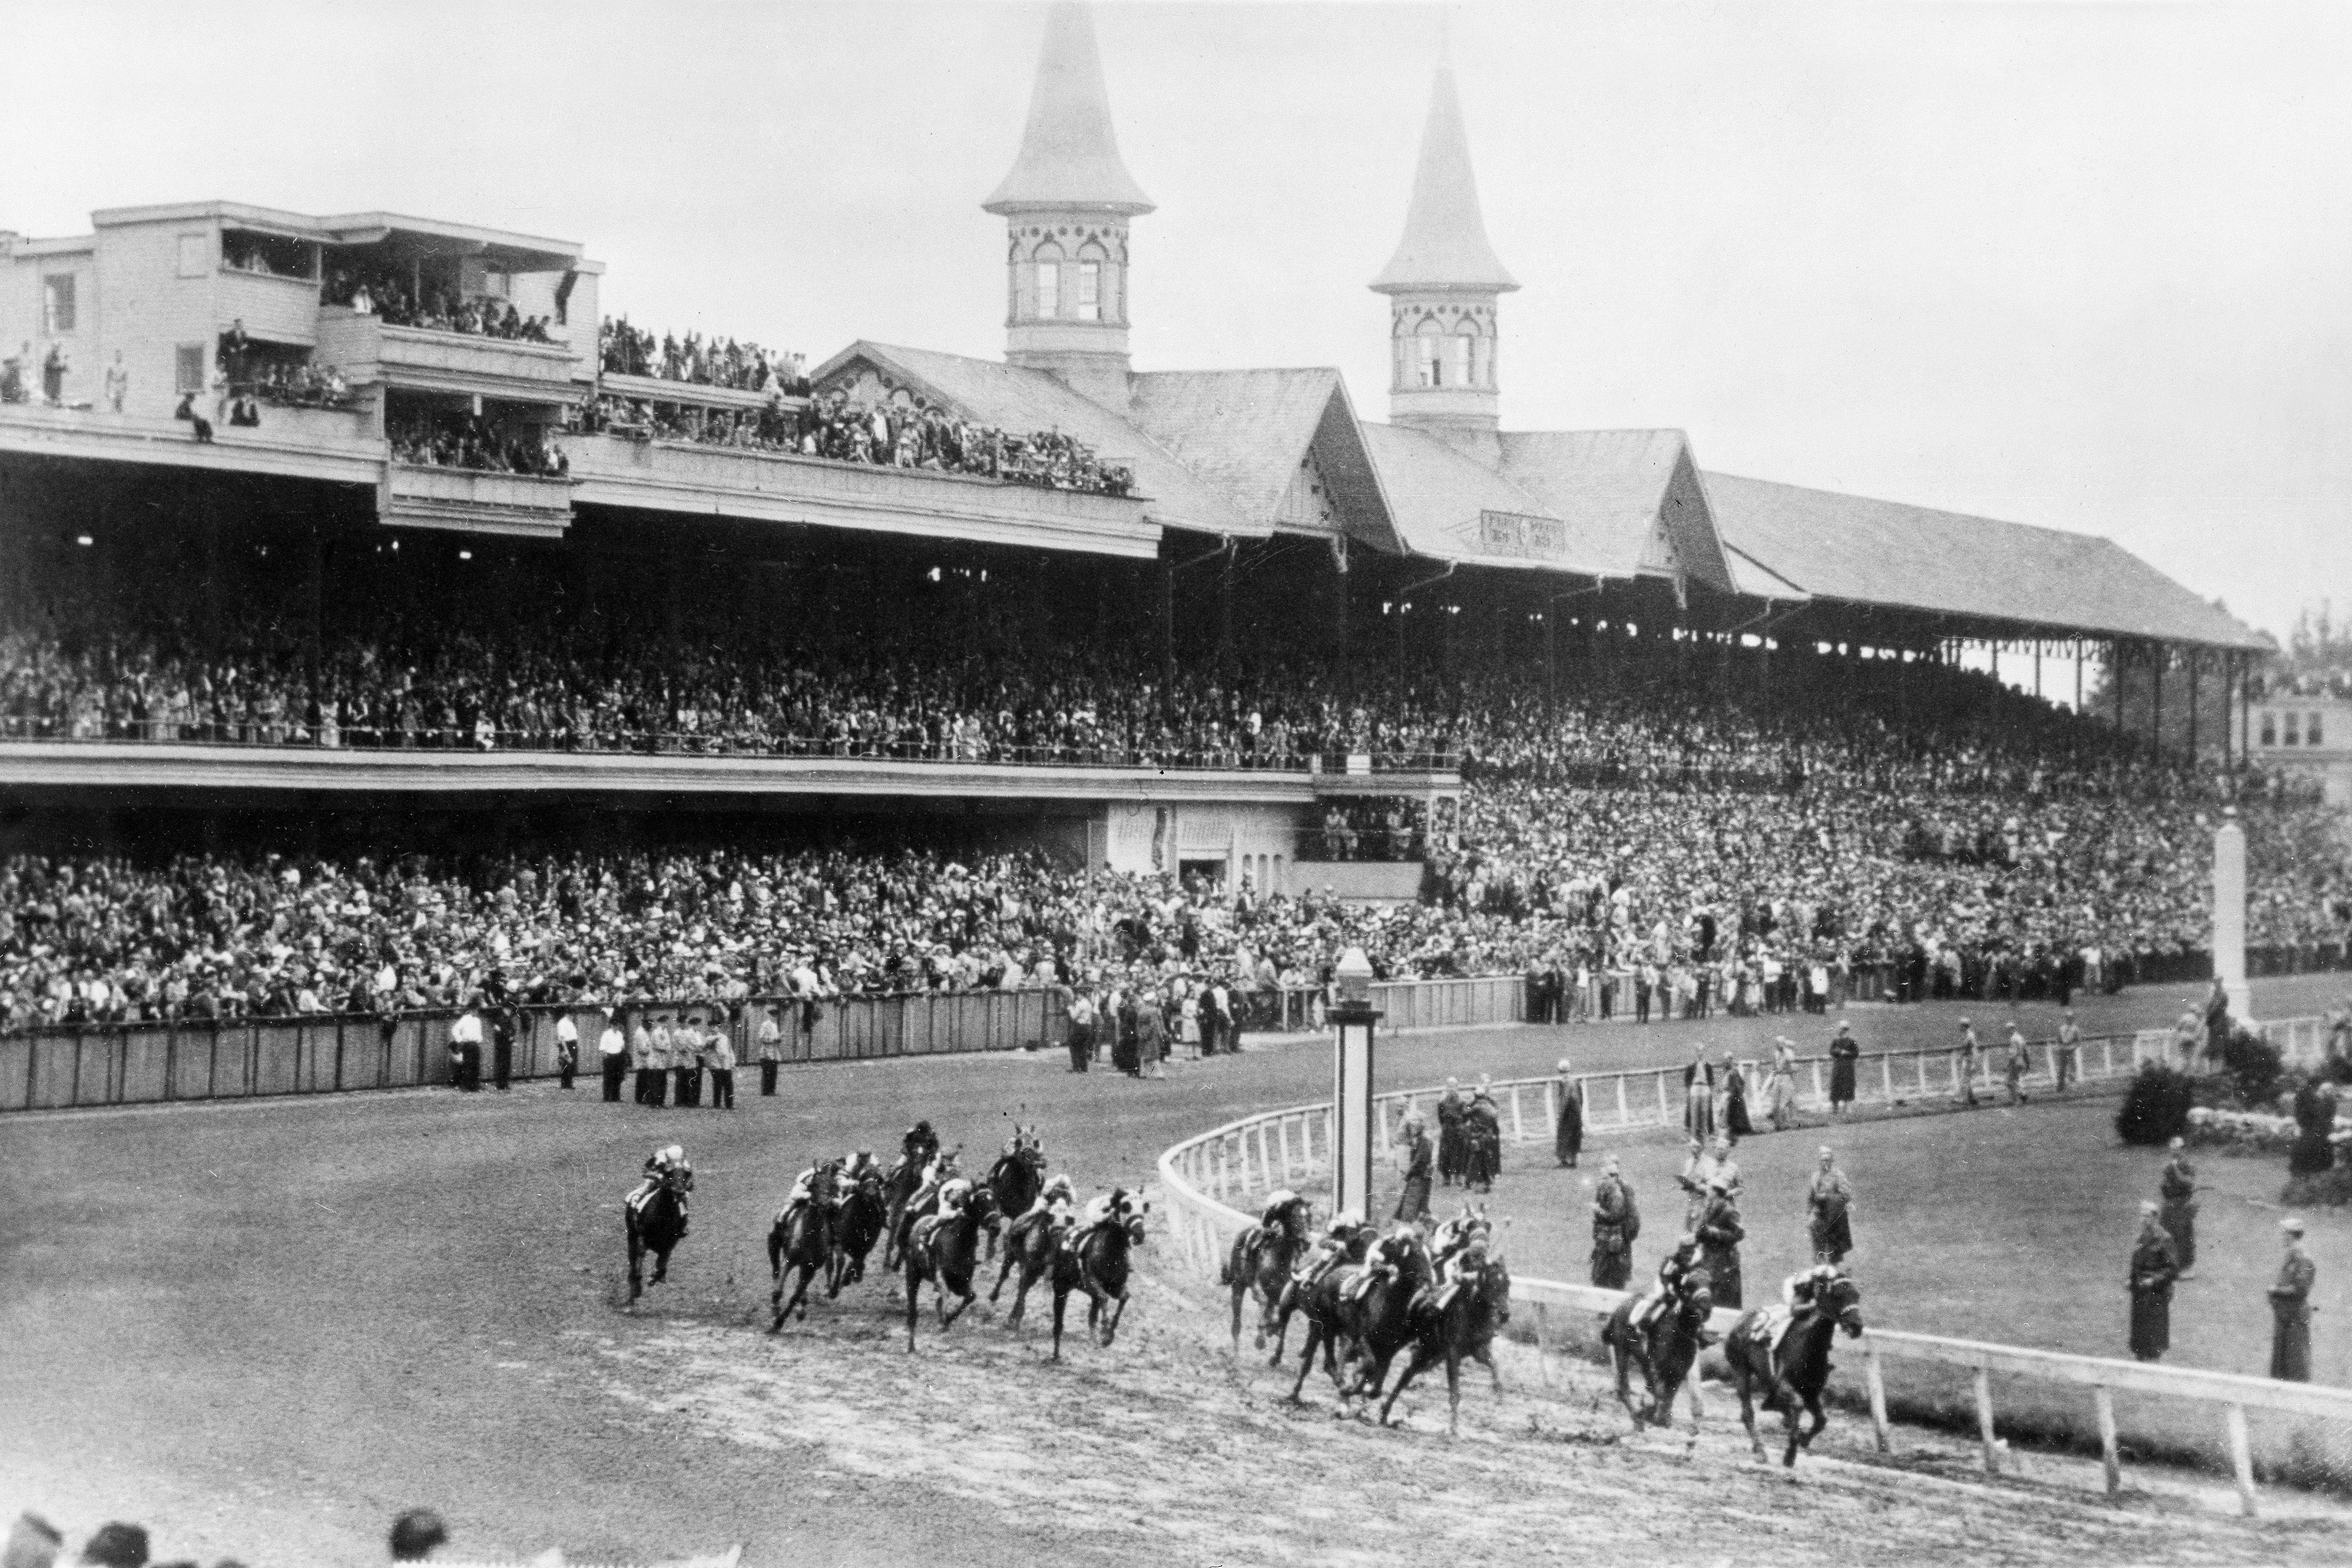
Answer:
[{"left": 1129, "top": 367, "right": 1402, "bottom": 548}]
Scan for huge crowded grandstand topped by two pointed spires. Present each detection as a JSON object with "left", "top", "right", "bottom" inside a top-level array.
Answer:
[{"left": 0, "top": 9, "right": 2352, "bottom": 1044}]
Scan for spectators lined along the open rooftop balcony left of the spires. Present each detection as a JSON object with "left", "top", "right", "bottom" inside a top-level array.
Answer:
[{"left": 581, "top": 390, "right": 1136, "bottom": 496}]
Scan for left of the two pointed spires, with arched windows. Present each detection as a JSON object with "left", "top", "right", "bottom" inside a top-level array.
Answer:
[{"left": 981, "top": 5, "right": 1153, "bottom": 409}]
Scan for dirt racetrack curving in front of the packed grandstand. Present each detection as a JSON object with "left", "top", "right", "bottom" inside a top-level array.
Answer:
[{"left": 0, "top": 978, "right": 2352, "bottom": 1566}]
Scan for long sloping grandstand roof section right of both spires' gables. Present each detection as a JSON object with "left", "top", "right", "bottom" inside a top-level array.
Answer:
[{"left": 1703, "top": 475, "right": 2272, "bottom": 651}]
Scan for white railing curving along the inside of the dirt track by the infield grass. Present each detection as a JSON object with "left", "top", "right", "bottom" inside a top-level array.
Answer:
[{"left": 1160, "top": 1018, "right": 2352, "bottom": 1514}]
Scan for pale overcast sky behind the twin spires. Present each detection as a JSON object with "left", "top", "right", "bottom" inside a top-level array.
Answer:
[{"left": 0, "top": 0, "right": 2352, "bottom": 632}]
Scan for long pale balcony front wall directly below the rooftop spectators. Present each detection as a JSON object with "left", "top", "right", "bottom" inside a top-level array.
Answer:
[{"left": 562, "top": 432, "right": 1160, "bottom": 557}]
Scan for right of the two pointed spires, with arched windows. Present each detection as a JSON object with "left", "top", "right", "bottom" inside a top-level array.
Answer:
[{"left": 1371, "top": 61, "right": 1519, "bottom": 463}]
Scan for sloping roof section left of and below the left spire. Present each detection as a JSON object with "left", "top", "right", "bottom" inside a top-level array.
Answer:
[{"left": 809, "top": 338, "right": 1261, "bottom": 536}]
